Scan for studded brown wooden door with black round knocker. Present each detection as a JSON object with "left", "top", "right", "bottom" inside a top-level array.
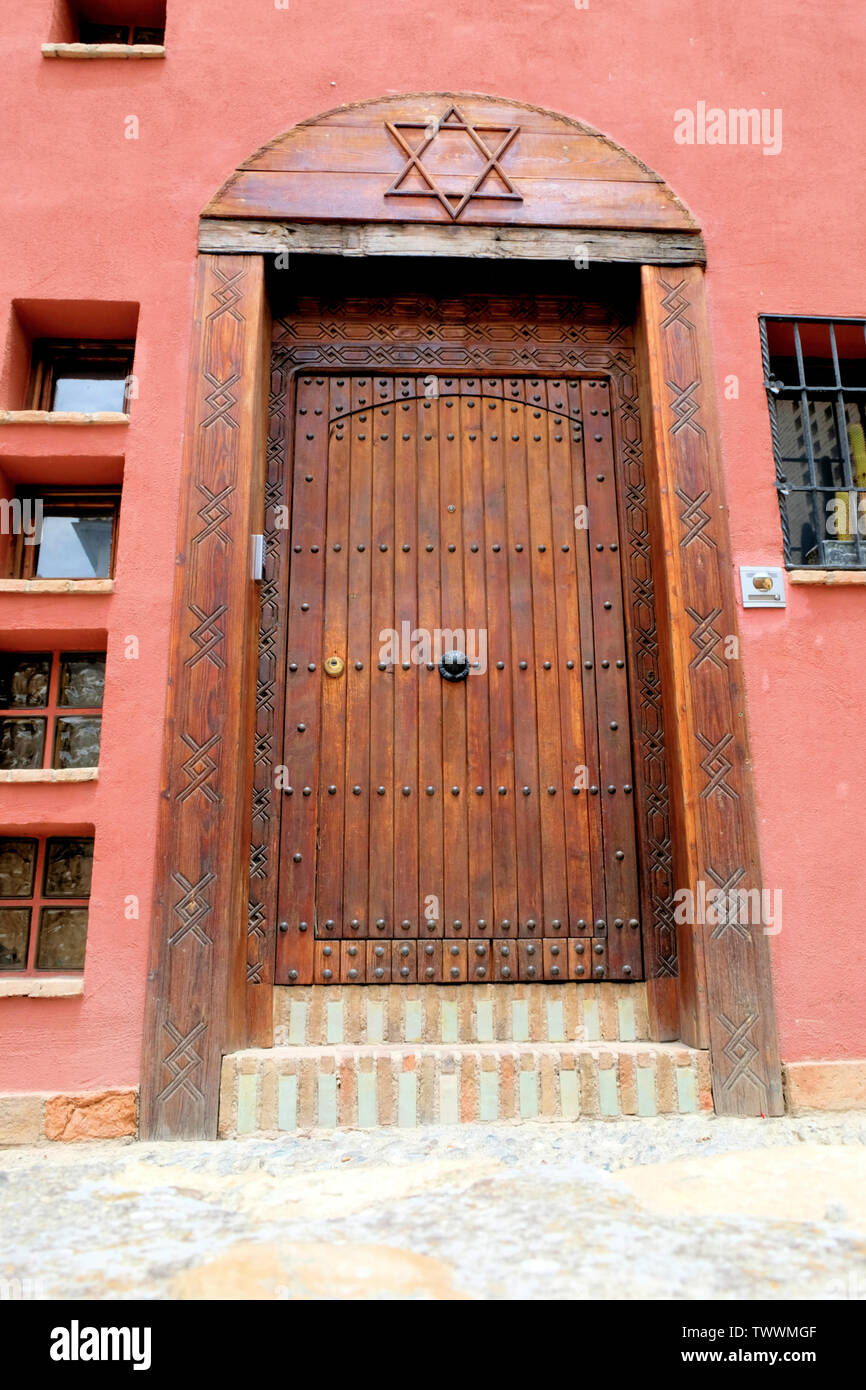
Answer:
[{"left": 277, "top": 374, "right": 642, "bottom": 983}]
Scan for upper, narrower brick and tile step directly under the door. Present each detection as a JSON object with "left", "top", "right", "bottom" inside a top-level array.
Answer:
[{"left": 274, "top": 981, "right": 648, "bottom": 1047}]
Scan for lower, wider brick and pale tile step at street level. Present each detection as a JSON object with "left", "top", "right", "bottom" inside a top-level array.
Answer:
[{"left": 220, "top": 1043, "right": 713, "bottom": 1138}]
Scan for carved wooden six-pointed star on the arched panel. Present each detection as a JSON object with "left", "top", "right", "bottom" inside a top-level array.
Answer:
[{"left": 385, "top": 106, "right": 523, "bottom": 222}]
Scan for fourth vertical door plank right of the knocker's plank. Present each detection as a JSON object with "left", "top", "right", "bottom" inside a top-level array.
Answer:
[{"left": 524, "top": 377, "right": 569, "bottom": 937}]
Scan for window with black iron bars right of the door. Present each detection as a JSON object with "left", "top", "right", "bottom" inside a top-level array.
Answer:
[{"left": 760, "top": 317, "right": 866, "bottom": 570}]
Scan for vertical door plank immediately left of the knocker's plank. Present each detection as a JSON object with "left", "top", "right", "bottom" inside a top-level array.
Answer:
[{"left": 417, "top": 375, "right": 445, "bottom": 945}]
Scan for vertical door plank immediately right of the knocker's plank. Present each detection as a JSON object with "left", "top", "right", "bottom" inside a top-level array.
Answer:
[{"left": 460, "top": 377, "right": 493, "bottom": 945}]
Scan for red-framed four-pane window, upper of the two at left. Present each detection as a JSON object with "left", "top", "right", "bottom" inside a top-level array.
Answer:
[{"left": 0, "top": 652, "right": 106, "bottom": 769}]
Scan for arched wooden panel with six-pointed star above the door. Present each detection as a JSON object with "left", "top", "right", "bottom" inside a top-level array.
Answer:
[{"left": 203, "top": 93, "right": 703, "bottom": 241}]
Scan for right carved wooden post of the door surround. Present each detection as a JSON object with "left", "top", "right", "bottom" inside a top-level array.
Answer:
[{"left": 641, "top": 265, "right": 784, "bottom": 1115}]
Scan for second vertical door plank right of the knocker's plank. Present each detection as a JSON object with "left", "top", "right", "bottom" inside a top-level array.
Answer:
[{"left": 481, "top": 377, "right": 517, "bottom": 937}]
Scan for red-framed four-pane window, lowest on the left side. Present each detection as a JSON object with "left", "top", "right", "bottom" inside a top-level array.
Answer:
[{"left": 0, "top": 835, "right": 93, "bottom": 974}]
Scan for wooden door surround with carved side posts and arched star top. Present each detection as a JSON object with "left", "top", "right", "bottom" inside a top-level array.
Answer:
[{"left": 142, "top": 93, "right": 781, "bottom": 1137}]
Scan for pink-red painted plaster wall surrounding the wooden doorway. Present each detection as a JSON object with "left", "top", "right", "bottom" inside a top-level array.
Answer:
[{"left": 0, "top": 0, "right": 866, "bottom": 1090}]
